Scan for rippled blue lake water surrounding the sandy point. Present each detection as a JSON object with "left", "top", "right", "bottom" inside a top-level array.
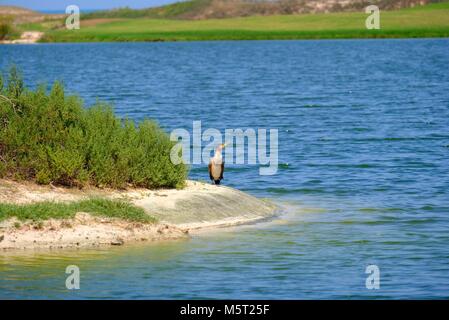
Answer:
[{"left": 0, "top": 39, "right": 449, "bottom": 299}]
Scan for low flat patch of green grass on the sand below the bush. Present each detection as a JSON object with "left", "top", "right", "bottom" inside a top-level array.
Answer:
[{"left": 0, "top": 198, "right": 156, "bottom": 222}]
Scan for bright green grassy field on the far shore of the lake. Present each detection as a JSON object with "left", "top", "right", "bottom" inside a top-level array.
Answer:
[{"left": 42, "top": 2, "right": 449, "bottom": 42}]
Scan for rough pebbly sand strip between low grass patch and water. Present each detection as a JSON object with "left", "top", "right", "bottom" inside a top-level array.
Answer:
[{"left": 0, "top": 212, "right": 188, "bottom": 249}]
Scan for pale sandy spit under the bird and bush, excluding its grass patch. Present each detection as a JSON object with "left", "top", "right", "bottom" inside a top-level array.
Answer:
[{"left": 0, "top": 180, "right": 276, "bottom": 250}]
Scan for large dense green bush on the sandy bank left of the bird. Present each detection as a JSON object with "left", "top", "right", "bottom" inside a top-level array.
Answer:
[{"left": 0, "top": 68, "right": 187, "bottom": 188}]
